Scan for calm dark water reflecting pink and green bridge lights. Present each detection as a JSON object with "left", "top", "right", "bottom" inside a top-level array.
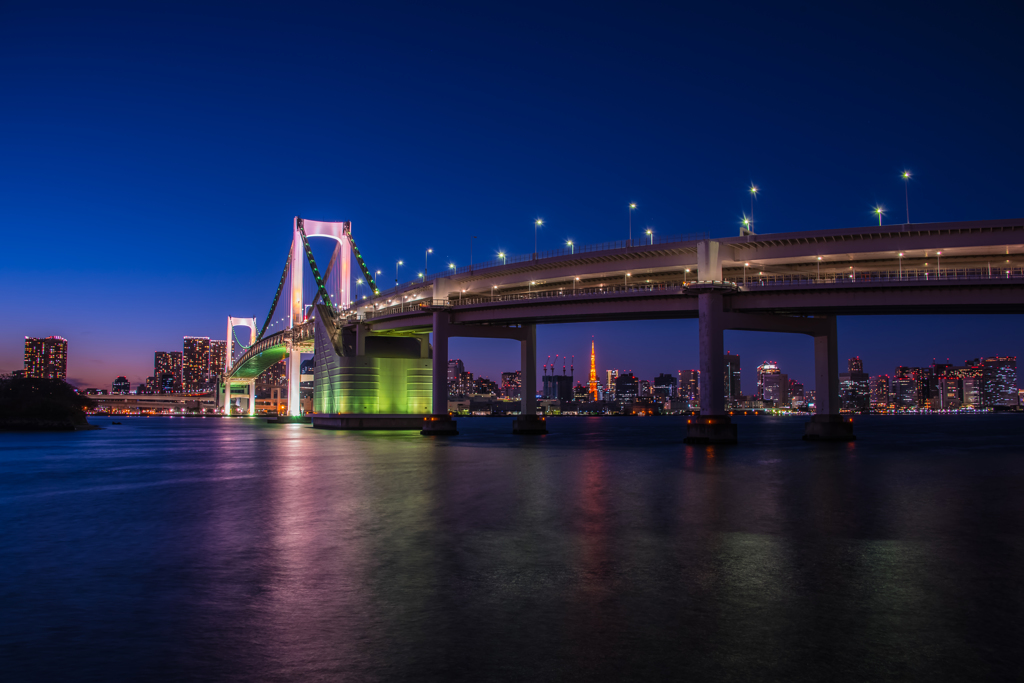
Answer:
[{"left": 0, "top": 416, "right": 1024, "bottom": 681}]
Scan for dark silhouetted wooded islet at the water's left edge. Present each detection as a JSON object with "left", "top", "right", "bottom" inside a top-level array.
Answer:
[{"left": 0, "top": 376, "right": 98, "bottom": 431}]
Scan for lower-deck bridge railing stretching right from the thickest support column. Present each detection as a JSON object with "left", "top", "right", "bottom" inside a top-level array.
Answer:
[{"left": 736, "top": 267, "right": 1024, "bottom": 289}]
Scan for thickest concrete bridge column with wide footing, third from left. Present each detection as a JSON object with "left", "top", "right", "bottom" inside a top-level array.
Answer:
[{"left": 683, "top": 290, "right": 736, "bottom": 443}]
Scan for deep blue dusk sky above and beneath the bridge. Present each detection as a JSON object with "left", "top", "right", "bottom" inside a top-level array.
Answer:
[{"left": 0, "top": 0, "right": 1024, "bottom": 392}]
